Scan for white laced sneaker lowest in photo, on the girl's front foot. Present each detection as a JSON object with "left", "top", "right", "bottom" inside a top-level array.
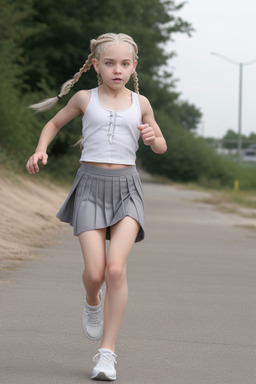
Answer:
[{"left": 91, "top": 348, "right": 117, "bottom": 381}]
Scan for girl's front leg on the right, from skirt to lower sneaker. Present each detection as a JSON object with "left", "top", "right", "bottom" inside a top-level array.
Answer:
[{"left": 101, "top": 216, "right": 139, "bottom": 351}]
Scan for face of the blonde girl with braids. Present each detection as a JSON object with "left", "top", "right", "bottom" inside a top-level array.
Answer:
[{"left": 93, "top": 43, "right": 137, "bottom": 89}]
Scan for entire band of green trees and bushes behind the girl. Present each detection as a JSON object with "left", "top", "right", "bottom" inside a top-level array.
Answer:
[{"left": 0, "top": 0, "right": 256, "bottom": 191}]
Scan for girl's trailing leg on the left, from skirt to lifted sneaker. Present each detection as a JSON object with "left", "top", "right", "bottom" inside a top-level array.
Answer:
[{"left": 79, "top": 229, "right": 106, "bottom": 306}]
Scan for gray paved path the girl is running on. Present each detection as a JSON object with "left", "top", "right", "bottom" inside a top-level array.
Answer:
[{"left": 0, "top": 184, "right": 256, "bottom": 384}]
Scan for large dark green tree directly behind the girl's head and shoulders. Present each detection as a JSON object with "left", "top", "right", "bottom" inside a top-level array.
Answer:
[{"left": 0, "top": 0, "right": 206, "bottom": 182}]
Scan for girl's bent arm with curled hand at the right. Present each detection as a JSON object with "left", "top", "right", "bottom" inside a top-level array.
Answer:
[{"left": 138, "top": 95, "right": 167, "bottom": 154}]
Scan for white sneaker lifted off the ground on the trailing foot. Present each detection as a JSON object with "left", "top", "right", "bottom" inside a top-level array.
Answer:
[{"left": 83, "top": 290, "right": 103, "bottom": 340}]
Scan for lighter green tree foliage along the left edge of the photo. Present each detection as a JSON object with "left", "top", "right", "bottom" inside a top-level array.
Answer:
[{"left": 0, "top": 0, "right": 41, "bottom": 162}]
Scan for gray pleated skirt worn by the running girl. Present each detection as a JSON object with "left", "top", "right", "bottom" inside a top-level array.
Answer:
[{"left": 57, "top": 163, "right": 144, "bottom": 242}]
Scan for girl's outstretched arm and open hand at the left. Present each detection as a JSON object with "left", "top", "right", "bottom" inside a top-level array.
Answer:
[{"left": 26, "top": 91, "right": 90, "bottom": 175}]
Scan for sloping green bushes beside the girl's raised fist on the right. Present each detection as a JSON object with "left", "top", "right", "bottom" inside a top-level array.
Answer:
[{"left": 140, "top": 115, "right": 235, "bottom": 185}]
